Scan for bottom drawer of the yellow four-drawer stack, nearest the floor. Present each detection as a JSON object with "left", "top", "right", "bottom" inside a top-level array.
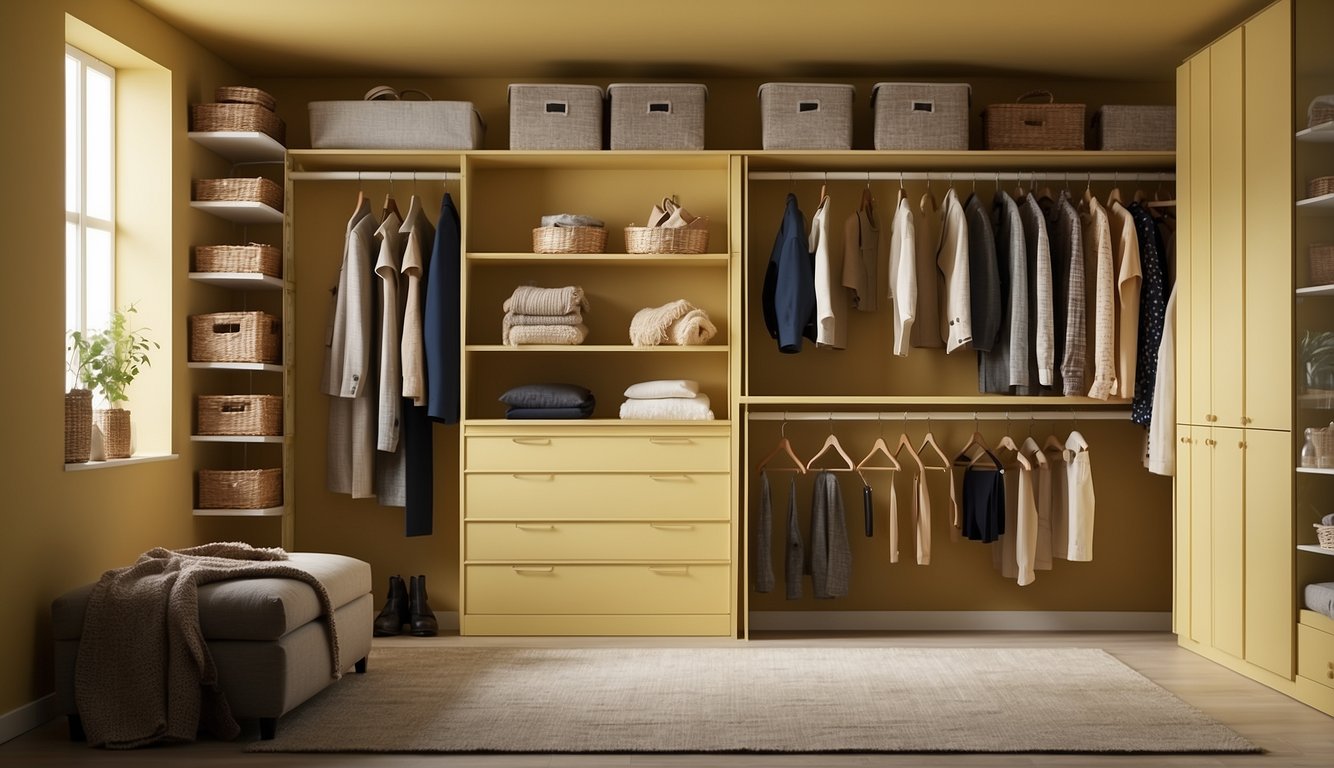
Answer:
[{"left": 463, "top": 563, "right": 731, "bottom": 615}]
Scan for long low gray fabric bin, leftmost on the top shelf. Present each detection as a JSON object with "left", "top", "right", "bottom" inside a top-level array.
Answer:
[{"left": 309, "top": 100, "right": 486, "bottom": 149}]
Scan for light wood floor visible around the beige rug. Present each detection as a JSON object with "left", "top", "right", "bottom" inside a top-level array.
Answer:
[{"left": 0, "top": 632, "right": 1334, "bottom": 768}]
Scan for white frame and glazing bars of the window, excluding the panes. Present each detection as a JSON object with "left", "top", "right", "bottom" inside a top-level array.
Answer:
[{"left": 65, "top": 44, "right": 116, "bottom": 388}]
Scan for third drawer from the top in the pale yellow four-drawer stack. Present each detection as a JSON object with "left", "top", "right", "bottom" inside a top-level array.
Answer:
[{"left": 464, "top": 521, "right": 731, "bottom": 563}]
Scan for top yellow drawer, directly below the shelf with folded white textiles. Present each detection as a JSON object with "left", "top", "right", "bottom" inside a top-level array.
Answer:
[{"left": 463, "top": 432, "right": 731, "bottom": 472}]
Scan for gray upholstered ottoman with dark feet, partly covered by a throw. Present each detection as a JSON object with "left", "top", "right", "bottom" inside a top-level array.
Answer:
[{"left": 51, "top": 552, "right": 375, "bottom": 739}]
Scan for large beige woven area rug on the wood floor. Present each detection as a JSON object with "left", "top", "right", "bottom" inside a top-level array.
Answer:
[{"left": 248, "top": 647, "right": 1258, "bottom": 753}]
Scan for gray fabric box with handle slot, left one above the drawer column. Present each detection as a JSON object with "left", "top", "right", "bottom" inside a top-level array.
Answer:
[{"left": 510, "top": 83, "right": 603, "bottom": 149}]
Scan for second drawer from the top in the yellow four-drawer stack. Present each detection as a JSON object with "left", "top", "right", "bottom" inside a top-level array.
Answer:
[{"left": 463, "top": 472, "right": 731, "bottom": 520}]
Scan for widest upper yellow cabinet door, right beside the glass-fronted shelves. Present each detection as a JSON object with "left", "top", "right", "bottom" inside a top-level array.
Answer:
[{"left": 1242, "top": 0, "right": 1294, "bottom": 431}]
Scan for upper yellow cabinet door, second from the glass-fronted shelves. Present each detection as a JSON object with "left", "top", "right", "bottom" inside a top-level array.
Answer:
[{"left": 1211, "top": 29, "right": 1247, "bottom": 427}]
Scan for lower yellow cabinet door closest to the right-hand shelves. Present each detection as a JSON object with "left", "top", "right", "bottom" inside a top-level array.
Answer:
[{"left": 1242, "top": 429, "right": 1297, "bottom": 680}]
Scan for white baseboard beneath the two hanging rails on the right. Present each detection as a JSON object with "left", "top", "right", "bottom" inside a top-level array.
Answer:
[{"left": 750, "top": 611, "right": 1171, "bottom": 632}]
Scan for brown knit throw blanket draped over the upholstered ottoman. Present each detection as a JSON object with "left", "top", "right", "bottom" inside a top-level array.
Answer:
[{"left": 75, "top": 541, "right": 343, "bottom": 749}]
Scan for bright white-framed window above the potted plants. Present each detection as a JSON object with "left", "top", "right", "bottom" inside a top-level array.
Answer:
[{"left": 65, "top": 45, "right": 116, "bottom": 388}]
